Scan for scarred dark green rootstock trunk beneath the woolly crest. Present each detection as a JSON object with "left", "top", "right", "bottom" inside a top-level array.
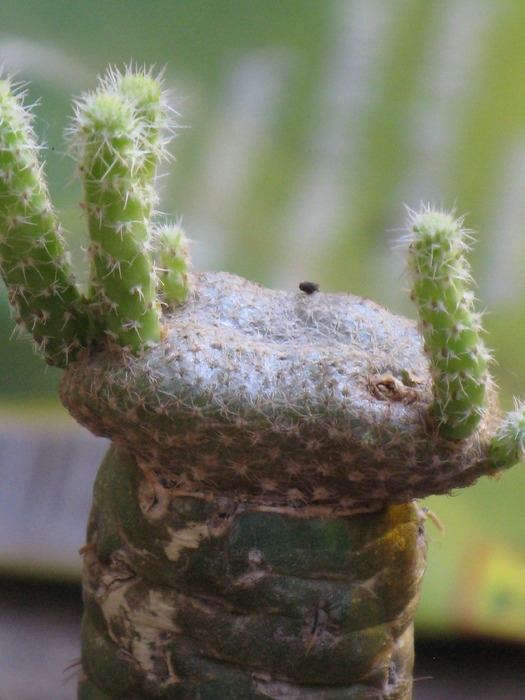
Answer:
[{"left": 79, "top": 448, "right": 426, "bottom": 700}]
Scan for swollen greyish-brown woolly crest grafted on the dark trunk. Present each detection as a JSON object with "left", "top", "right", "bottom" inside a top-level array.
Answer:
[{"left": 61, "top": 273, "right": 499, "bottom": 508}]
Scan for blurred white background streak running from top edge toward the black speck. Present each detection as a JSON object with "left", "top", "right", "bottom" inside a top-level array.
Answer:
[{"left": 271, "top": 0, "right": 392, "bottom": 288}]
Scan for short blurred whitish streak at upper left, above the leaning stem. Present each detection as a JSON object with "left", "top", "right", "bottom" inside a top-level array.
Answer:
[{"left": 0, "top": 36, "right": 93, "bottom": 92}]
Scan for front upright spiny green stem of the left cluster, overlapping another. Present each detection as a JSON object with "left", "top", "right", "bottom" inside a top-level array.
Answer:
[{"left": 70, "top": 89, "right": 161, "bottom": 351}]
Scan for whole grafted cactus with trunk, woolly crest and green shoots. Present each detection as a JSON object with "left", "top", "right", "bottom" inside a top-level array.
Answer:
[{"left": 0, "top": 69, "right": 525, "bottom": 699}]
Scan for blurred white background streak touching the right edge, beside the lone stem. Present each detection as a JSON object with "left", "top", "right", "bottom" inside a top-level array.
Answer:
[{"left": 480, "top": 134, "right": 525, "bottom": 306}]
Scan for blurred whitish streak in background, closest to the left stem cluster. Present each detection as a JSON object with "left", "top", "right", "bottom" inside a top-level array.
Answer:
[{"left": 185, "top": 48, "right": 293, "bottom": 267}]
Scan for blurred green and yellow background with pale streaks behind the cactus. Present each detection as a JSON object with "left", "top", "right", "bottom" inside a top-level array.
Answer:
[{"left": 0, "top": 0, "right": 525, "bottom": 640}]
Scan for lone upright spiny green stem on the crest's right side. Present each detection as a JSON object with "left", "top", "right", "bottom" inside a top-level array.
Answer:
[{"left": 407, "top": 209, "right": 489, "bottom": 440}]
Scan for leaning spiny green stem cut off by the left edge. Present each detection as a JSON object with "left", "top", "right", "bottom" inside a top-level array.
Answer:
[{"left": 0, "top": 80, "right": 89, "bottom": 367}]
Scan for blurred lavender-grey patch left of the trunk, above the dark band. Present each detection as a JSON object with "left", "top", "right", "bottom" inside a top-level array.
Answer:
[{"left": 0, "top": 419, "right": 108, "bottom": 578}]
